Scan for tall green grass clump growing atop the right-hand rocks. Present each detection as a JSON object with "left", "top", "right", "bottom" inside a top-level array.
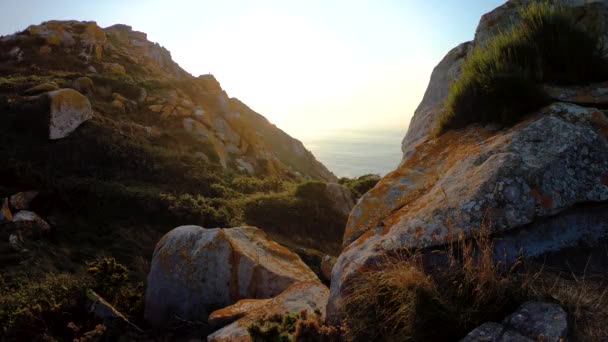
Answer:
[{"left": 434, "top": 2, "right": 608, "bottom": 135}]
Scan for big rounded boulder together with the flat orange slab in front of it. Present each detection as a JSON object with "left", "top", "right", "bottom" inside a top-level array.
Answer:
[{"left": 145, "top": 226, "right": 329, "bottom": 341}]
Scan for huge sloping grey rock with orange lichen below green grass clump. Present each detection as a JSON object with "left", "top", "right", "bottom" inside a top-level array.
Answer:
[{"left": 330, "top": 103, "right": 608, "bottom": 322}]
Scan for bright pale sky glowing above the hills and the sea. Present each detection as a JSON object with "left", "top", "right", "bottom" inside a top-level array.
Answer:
[{"left": 0, "top": 0, "right": 504, "bottom": 137}]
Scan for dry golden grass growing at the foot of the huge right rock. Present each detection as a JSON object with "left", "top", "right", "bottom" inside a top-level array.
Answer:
[{"left": 340, "top": 218, "right": 608, "bottom": 341}]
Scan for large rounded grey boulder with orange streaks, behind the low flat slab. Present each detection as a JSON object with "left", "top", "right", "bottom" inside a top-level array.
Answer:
[{"left": 145, "top": 226, "right": 318, "bottom": 326}]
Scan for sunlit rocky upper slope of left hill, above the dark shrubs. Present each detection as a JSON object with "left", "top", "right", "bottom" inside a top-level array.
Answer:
[{"left": 0, "top": 21, "right": 336, "bottom": 181}]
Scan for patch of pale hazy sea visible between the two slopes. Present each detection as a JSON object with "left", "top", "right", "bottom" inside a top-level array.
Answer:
[{"left": 300, "top": 129, "right": 405, "bottom": 178}]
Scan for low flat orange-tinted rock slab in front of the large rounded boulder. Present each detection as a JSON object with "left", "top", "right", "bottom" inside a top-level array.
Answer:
[{"left": 207, "top": 281, "right": 329, "bottom": 342}]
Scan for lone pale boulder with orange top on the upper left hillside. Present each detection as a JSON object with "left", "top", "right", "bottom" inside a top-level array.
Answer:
[{"left": 47, "top": 89, "right": 93, "bottom": 140}]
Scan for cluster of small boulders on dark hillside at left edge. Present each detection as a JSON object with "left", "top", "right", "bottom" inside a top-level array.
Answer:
[{"left": 0, "top": 191, "right": 51, "bottom": 252}]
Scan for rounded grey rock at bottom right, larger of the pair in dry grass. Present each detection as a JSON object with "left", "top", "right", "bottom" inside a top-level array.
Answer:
[{"left": 503, "top": 302, "right": 568, "bottom": 342}]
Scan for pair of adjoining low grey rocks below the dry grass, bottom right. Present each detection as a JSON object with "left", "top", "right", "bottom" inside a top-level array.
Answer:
[{"left": 461, "top": 302, "right": 568, "bottom": 342}]
